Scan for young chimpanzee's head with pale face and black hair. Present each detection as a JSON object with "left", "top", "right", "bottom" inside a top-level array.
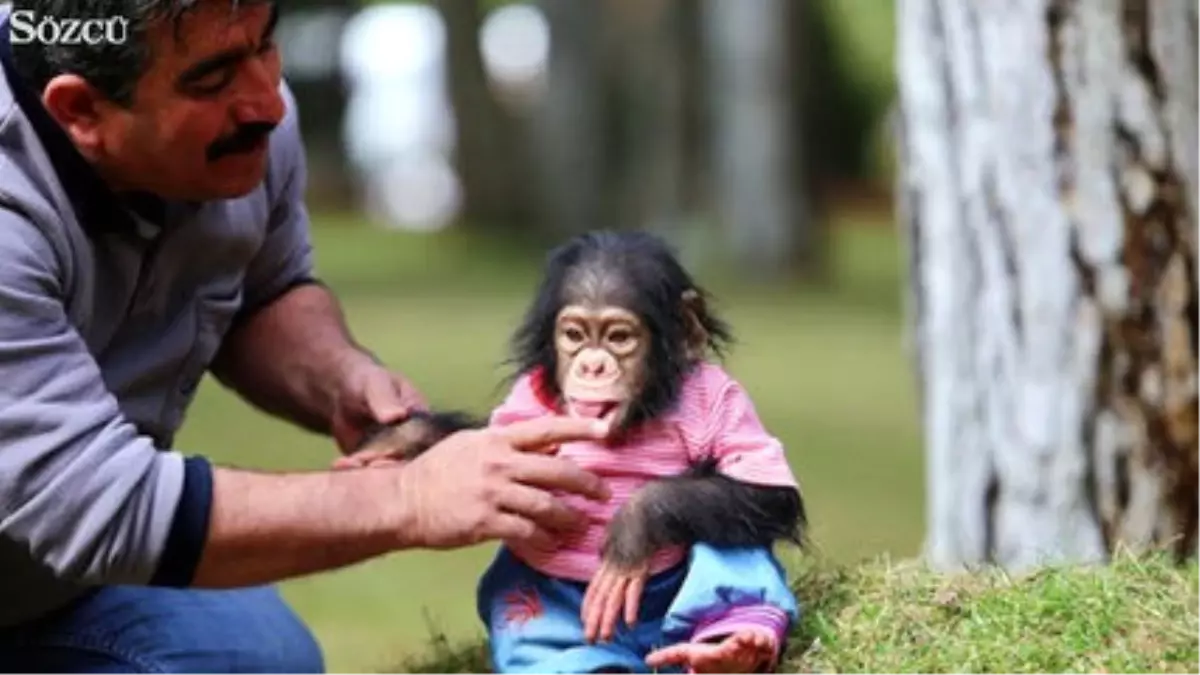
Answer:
[{"left": 514, "top": 232, "right": 732, "bottom": 438}]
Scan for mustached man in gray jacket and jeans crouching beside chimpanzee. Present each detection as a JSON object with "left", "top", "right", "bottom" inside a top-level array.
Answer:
[{"left": 0, "top": 0, "right": 606, "bottom": 674}]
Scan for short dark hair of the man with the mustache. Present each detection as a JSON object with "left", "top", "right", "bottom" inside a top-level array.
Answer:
[{"left": 12, "top": 0, "right": 267, "bottom": 106}]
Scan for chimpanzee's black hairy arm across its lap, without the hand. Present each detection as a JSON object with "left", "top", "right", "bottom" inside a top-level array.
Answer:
[{"left": 604, "top": 460, "right": 808, "bottom": 568}]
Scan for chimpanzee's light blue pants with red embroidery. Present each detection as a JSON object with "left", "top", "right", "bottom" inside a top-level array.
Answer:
[{"left": 476, "top": 544, "right": 800, "bottom": 675}]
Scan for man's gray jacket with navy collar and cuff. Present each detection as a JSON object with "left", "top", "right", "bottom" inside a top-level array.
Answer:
[{"left": 0, "top": 8, "right": 313, "bottom": 626}]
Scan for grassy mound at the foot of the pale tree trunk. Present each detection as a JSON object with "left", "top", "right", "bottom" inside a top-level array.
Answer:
[{"left": 388, "top": 555, "right": 1200, "bottom": 675}]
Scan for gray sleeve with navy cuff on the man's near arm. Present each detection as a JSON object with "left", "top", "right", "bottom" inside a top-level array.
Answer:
[{"left": 0, "top": 210, "right": 211, "bottom": 586}]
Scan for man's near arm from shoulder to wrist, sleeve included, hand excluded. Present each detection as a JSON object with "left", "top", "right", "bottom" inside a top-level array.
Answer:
[{"left": 0, "top": 210, "right": 407, "bottom": 586}]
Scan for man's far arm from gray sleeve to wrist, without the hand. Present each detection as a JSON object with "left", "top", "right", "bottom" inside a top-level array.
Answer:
[{"left": 211, "top": 79, "right": 374, "bottom": 434}]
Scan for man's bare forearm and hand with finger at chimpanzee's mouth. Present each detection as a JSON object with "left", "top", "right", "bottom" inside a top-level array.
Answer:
[{"left": 193, "top": 417, "right": 608, "bottom": 587}]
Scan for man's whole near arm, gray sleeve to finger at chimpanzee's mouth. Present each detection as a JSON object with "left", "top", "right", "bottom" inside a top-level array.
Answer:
[{"left": 0, "top": 209, "right": 607, "bottom": 587}]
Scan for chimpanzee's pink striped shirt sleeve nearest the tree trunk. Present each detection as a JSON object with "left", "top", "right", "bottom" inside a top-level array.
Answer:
[{"left": 703, "top": 378, "right": 797, "bottom": 488}]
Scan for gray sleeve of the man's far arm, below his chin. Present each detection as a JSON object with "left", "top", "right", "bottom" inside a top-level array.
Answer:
[{"left": 230, "top": 83, "right": 318, "bottom": 319}]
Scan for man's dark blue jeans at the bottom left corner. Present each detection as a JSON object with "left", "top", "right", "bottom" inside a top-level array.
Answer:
[{"left": 0, "top": 586, "right": 324, "bottom": 675}]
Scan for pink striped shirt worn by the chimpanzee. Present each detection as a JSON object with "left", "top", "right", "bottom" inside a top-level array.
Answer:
[{"left": 491, "top": 363, "right": 797, "bottom": 583}]
